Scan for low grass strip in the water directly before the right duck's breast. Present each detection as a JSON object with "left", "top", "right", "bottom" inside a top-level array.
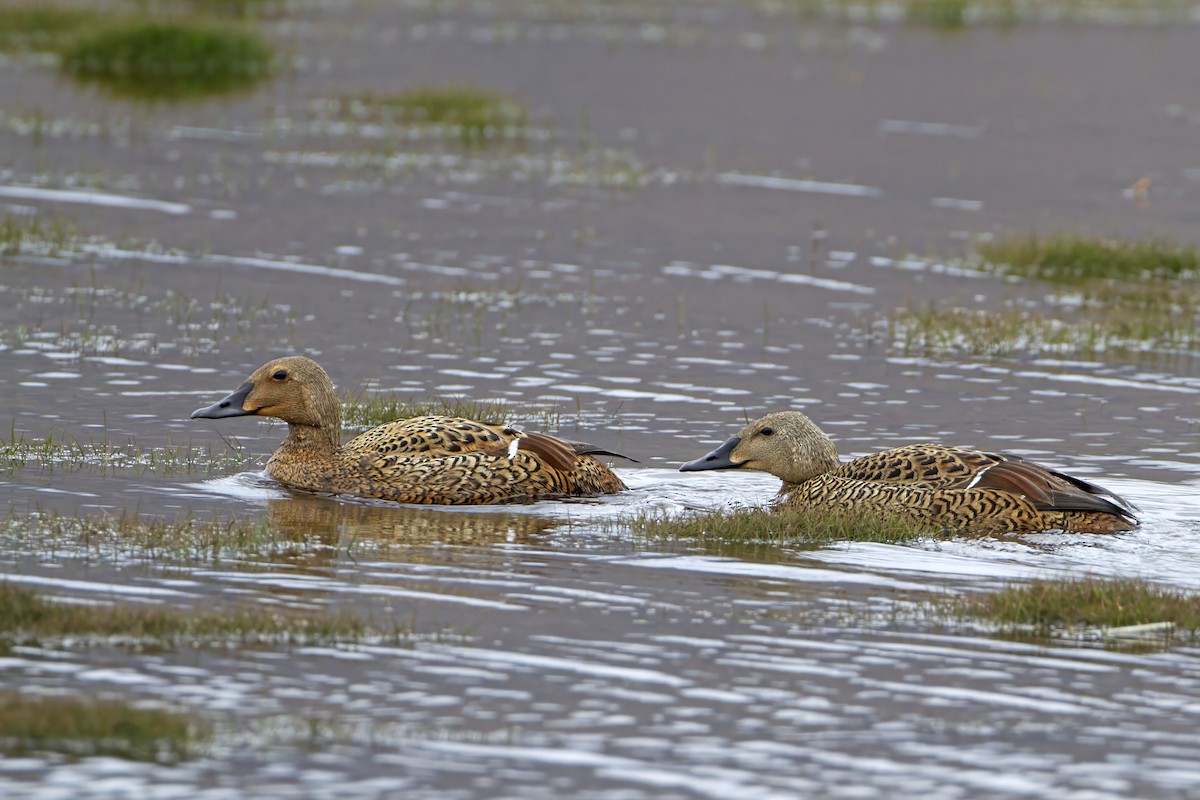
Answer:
[{"left": 629, "top": 506, "right": 935, "bottom": 546}]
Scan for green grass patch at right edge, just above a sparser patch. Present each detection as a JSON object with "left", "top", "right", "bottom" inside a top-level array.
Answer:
[{"left": 977, "top": 234, "right": 1200, "bottom": 285}]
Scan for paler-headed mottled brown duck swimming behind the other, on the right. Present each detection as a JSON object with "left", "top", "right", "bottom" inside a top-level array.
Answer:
[{"left": 679, "top": 411, "right": 1138, "bottom": 535}]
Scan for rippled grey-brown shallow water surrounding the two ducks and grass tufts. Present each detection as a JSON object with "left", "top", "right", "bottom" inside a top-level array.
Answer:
[{"left": 0, "top": 2, "right": 1200, "bottom": 800}]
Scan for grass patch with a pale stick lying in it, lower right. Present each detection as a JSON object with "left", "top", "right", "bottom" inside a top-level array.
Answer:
[{"left": 948, "top": 577, "right": 1200, "bottom": 642}]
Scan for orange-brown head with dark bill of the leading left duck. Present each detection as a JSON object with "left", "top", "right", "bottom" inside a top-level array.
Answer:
[{"left": 192, "top": 355, "right": 342, "bottom": 441}]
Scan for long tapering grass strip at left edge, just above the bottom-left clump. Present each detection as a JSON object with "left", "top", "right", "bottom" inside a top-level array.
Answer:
[{"left": 0, "top": 581, "right": 409, "bottom": 648}]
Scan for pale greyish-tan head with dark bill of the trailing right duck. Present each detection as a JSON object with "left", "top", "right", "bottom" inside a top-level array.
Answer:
[{"left": 679, "top": 411, "right": 838, "bottom": 483}]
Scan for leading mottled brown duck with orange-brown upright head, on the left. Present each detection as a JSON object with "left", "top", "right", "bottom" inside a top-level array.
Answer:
[{"left": 192, "top": 355, "right": 632, "bottom": 505}]
